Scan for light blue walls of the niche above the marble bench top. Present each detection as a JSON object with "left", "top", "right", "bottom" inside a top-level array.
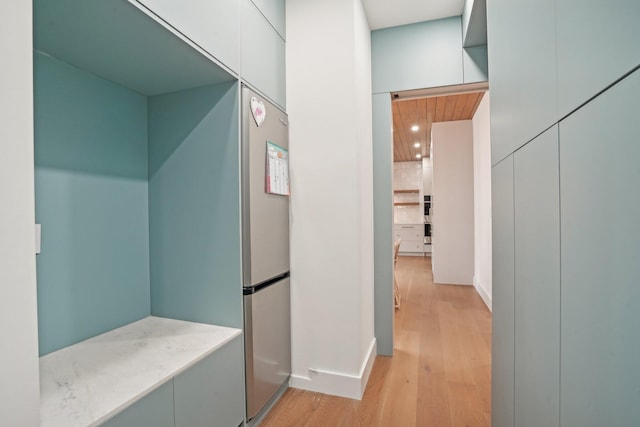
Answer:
[{"left": 34, "top": 52, "right": 242, "bottom": 355}]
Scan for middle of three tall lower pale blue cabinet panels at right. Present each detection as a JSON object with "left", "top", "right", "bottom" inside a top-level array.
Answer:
[{"left": 514, "top": 126, "right": 560, "bottom": 427}]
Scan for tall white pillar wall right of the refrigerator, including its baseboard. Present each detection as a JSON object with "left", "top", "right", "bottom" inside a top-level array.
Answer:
[{"left": 286, "top": 0, "right": 375, "bottom": 398}]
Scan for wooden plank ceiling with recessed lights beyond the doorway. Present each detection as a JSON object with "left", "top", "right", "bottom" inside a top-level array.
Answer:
[{"left": 392, "top": 92, "right": 484, "bottom": 162}]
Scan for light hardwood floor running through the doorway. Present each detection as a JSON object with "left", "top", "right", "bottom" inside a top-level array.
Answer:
[{"left": 260, "top": 257, "right": 491, "bottom": 427}]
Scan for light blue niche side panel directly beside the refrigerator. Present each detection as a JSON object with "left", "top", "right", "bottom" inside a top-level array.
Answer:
[{"left": 149, "top": 83, "right": 242, "bottom": 327}]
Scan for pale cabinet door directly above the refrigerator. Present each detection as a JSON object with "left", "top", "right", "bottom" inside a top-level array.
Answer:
[{"left": 240, "top": 0, "right": 286, "bottom": 109}]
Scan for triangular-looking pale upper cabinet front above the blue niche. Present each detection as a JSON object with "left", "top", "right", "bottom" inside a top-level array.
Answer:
[{"left": 129, "top": 0, "right": 240, "bottom": 72}]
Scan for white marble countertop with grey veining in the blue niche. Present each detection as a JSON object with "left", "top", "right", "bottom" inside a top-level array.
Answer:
[{"left": 40, "top": 316, "right": 240, "bottom": 427}]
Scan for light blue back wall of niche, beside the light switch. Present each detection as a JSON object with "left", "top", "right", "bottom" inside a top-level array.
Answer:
[{"left": 34, "top": 54, "right": 150, "bottom": 354}]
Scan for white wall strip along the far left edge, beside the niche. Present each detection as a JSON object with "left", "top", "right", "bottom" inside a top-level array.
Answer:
[{"left": 0, "top": 1, "right": 40, "bottom": 427}]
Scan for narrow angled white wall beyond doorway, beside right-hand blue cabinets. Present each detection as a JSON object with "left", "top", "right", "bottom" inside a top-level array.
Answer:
[{"left": 473, "top": 92, "right": 492, "bottom": 310}]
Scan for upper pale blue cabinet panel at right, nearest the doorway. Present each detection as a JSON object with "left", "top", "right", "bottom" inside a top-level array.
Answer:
[{"left": 487, "top": 0, "right": 556, "bottom": 165}]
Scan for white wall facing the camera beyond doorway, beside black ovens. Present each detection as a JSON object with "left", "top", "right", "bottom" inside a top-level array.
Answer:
[{"left": 431, "top": 120, "right": 474, "bottom": 285}]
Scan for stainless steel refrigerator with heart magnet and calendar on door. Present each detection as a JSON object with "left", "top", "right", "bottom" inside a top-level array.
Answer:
[{"left": 242, "top": 87, "right": 291, "bottom": 421}]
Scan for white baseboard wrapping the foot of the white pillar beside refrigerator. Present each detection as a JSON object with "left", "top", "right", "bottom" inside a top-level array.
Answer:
[{"left": 289, "top": 338, "right": 376, "bottom": 400}]
